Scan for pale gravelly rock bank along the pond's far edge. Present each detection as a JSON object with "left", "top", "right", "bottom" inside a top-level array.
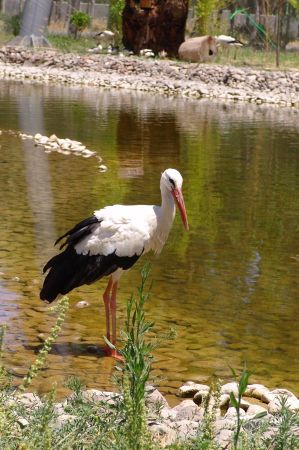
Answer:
[{"left": 0, "top": 47, "right": 299, "bottom": 108}]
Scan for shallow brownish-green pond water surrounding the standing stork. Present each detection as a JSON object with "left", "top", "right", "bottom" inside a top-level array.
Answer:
[{"left": 0, "top": 82, "right": 299, "bottom": 398}]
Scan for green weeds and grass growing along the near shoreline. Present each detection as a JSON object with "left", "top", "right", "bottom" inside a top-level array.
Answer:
[{"left": 0, "top": 269, "right": 299, "bottom": 450}]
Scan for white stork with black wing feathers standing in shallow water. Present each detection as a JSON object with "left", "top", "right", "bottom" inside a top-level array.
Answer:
[{"left": 40, "top": 169, "right": 189, "bottom": 358}]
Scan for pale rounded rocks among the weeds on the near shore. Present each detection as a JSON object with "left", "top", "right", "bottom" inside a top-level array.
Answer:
[{"left": 10, "top": 381, "right": 299, "bottom": 449}]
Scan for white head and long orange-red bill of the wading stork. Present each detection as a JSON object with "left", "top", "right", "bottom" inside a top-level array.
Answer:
[{"left": 160, "top": 169, "right": 189, "bottom": 230}]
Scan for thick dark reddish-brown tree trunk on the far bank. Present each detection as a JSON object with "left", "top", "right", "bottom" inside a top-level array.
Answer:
[{"left": 122, "top": 0, "right": 188, "bottom": 56}]
